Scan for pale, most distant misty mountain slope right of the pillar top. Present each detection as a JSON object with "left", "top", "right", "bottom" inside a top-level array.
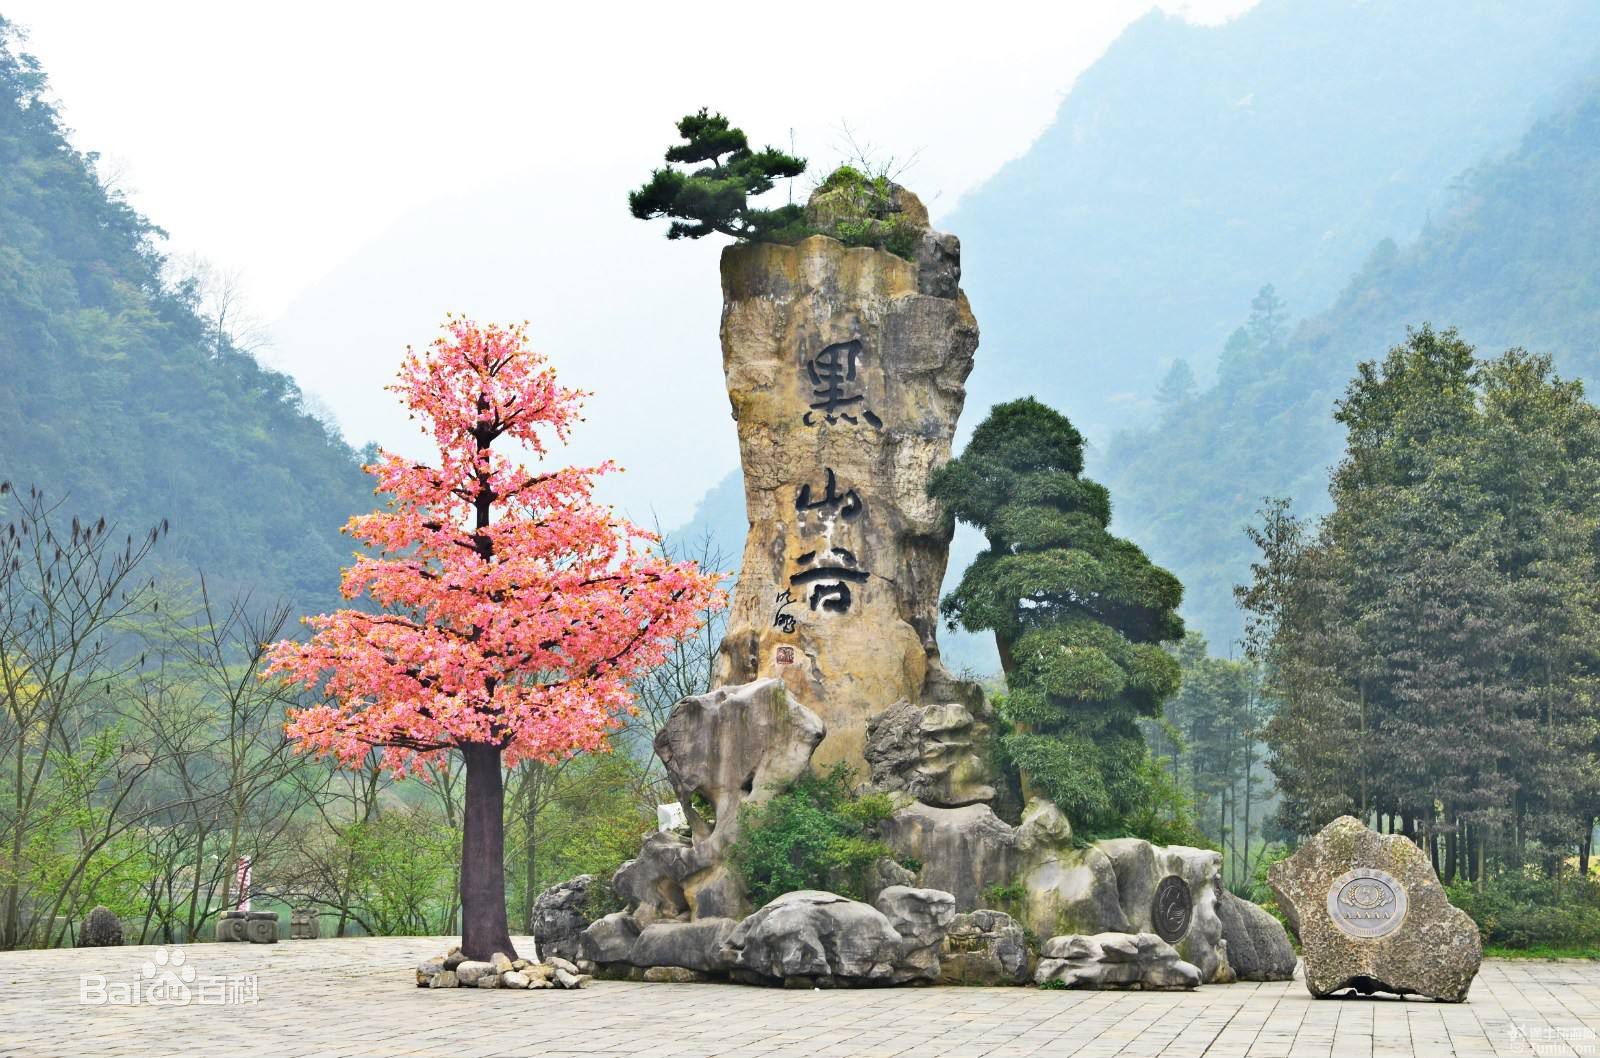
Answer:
[{"left": 942, "top": 0, "right": 1600, "bottom": 439}]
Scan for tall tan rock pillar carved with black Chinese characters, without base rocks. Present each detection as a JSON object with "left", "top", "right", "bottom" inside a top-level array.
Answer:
[{"left": 717, "top": 189, "right": 981, "bottom": 775}]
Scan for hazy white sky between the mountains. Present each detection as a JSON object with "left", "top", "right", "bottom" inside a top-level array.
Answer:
[{"left": 5, "top": 0, "right": 1254, "bottom": 523}]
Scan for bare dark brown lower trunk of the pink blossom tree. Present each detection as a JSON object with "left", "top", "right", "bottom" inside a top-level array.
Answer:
[{"left": 461, "top": 743, "right": 517, "bottom": 960}]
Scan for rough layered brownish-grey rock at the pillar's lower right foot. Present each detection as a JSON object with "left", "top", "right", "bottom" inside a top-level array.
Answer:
[{"left": 866, "top": 701, "right": 995, "bottom": 808}]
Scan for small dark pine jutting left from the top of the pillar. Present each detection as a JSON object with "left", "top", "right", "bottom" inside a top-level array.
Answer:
[{"left": 627, "top": 107, "right": 805, "bottom": 242}]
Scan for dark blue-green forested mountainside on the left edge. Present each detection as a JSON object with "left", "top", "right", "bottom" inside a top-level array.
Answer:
[{"left": 0, "top": 19, "right": 373, "bottom": 611}]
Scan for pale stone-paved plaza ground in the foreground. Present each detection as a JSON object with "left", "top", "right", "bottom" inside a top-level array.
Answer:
[{"left": 0, "top": 938, "right": 1600, "bottom": 1058}]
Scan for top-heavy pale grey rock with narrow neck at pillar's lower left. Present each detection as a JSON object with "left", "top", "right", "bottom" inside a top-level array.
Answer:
[{"left": 627, "top": 679, "right": 824, "bottom": 925}]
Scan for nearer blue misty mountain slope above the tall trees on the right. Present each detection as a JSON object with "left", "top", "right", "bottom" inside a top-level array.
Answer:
[{"left": 1091, "top": 72, "right": 1600, "bottom": 650}]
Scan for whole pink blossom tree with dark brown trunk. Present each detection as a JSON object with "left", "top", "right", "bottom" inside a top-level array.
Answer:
[{"left": 269, "top": 319, "right": 723, "bottom": 959}]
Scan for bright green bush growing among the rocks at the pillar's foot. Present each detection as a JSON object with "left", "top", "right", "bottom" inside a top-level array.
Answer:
[{"left": 730, "top": 763, "right": 894, "bottom": 904}]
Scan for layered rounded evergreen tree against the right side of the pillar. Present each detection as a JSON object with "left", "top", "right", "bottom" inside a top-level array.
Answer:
[{"left": 930, "top": 399, "right": 1184, "bottom": 834}]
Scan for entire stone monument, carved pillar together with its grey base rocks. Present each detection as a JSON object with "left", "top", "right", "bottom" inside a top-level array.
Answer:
[{"left": 578, "top": 177, "right": 1294, "bottom": 988}]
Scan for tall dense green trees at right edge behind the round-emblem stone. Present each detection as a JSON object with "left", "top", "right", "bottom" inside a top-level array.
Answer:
[{"left": 1240, "top": 327, "right": 1600, "bottom": 879}]
